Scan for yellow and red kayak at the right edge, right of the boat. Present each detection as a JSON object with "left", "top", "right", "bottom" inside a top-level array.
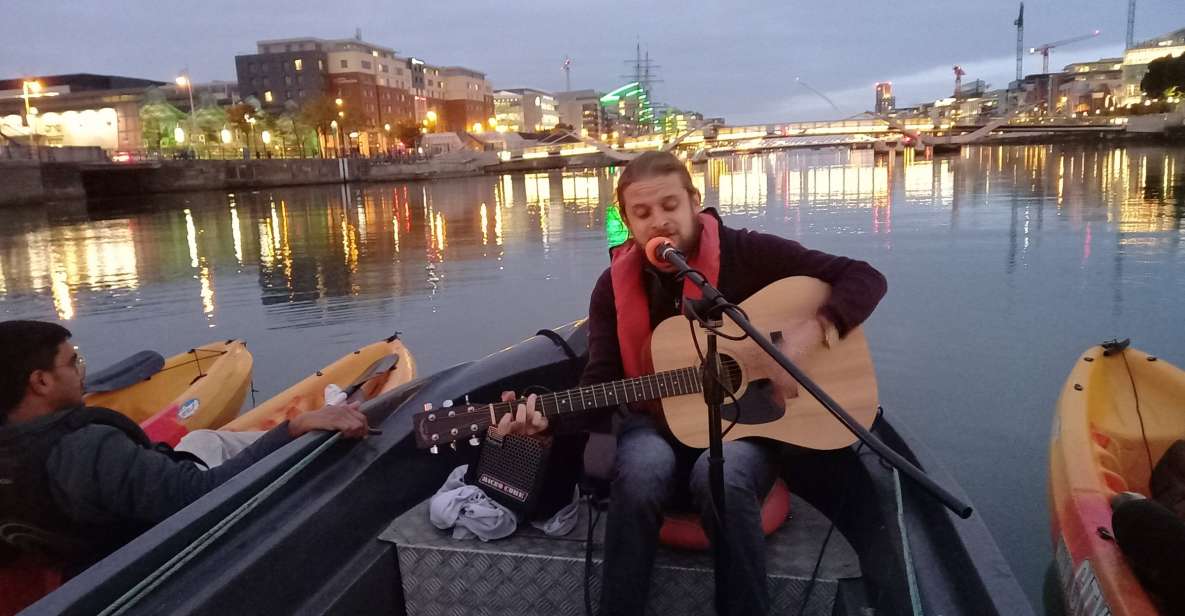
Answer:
[{"left": 1049, "top": 342, "right": 1185, "bottom": 616}]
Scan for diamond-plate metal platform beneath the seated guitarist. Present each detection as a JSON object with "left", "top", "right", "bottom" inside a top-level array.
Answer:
[{"left": 379, "top": 496, "right": 860, "bottom": 616}]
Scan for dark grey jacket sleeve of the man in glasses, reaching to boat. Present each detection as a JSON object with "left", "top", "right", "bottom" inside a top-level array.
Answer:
[{"left": 46, "top": 422, "right": 292, "bottom": 525}]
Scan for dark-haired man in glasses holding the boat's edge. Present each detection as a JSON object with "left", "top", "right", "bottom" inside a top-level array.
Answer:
[{"left": 0, "top": 321, "right": 369, "bottom": 577}]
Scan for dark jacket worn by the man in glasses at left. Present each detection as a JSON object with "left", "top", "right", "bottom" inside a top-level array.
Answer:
[{"left": 0, "top": 408, "right": 289, "bottom": 570}]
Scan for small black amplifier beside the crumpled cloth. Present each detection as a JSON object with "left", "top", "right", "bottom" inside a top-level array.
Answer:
[{"left": 468, "top": 429, "right": 551, "bottom": 519}]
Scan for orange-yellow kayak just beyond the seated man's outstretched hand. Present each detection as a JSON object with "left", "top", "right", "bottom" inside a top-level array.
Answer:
[{"left": 222, "top": 336, "right": 416, "bottom": 431}]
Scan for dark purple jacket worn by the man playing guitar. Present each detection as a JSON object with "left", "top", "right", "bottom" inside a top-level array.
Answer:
[{"left": 581, "top": 208, "right": 888, "bottom": 386}]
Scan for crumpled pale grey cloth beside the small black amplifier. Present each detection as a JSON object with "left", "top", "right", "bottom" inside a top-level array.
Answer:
[{"left": 428, "top": 464, "right": 518, "bottom": 541}]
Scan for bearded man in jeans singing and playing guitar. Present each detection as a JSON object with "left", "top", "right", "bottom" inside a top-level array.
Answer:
[{"left": 498, "top": 152, "right": 886, "bottom": 615}]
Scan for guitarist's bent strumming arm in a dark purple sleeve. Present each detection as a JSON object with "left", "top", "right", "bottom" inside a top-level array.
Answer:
[{"left": 737, "top": 230, "right": 888, "bottom": 336}]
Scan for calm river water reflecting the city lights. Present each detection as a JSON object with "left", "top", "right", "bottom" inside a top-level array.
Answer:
[{"left": 0, "top": 146, "right": 1185, "bottom": 604}]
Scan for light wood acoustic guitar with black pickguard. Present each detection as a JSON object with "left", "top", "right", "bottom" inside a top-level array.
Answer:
[{"left": 412, "top": 276, "right": 877, "bottom": 450}]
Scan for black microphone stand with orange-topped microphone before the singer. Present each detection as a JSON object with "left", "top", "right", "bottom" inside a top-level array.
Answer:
[{"left": 656, "top": 244, "right": 972, "bottom": 521}]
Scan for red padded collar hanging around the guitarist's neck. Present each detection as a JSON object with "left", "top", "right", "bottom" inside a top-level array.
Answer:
[{"left": 609, "top": 212, "right": 720, "bottom": 378}]
